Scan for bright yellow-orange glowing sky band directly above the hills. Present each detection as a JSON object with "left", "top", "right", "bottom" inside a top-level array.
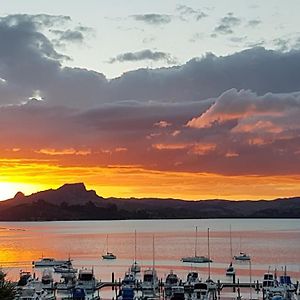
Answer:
[{"left": 0, "top": 160, "right": 300, "bottom": 200}]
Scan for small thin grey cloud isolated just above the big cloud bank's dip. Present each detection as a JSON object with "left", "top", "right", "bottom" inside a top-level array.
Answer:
[{"left": 109, "top": 49, "right": 176, "bottom": 64}]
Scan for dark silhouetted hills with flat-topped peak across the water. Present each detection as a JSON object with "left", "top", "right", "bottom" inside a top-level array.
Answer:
[{"left": 0, "top": 183, "right": 300, "bottom": 221}]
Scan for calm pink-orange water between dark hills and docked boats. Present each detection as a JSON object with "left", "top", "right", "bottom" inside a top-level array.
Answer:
[{"left": 0, "top": 219, "right": 300, "bottom": 281}]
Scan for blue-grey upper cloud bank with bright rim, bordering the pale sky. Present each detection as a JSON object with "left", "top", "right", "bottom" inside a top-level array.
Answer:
[{"left": 0, "top": 13, "right": 300, "bottom": 109}]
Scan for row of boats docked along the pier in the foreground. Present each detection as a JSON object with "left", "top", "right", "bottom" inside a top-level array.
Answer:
[{"left": 7, "top": 258, "right": 300, "bottom": 300}]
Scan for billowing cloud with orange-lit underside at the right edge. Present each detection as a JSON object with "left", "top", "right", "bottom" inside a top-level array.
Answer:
[{"left": 187, "top": 89, "right": 300, "bottom": 131}]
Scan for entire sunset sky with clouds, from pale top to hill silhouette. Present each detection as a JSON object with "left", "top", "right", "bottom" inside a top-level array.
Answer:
[{"left": 0, "top": 0, "right": 300, "bottom": 200}]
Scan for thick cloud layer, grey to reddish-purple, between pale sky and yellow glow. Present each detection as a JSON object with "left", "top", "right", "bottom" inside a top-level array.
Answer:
[{"left": 0, "top": 16, "right": 300, "bottom": 174}]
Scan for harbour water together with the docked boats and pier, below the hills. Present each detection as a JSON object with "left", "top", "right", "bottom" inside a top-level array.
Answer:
[{"left": 0, "top": 220, "right": 300, "bottom": 300}]
